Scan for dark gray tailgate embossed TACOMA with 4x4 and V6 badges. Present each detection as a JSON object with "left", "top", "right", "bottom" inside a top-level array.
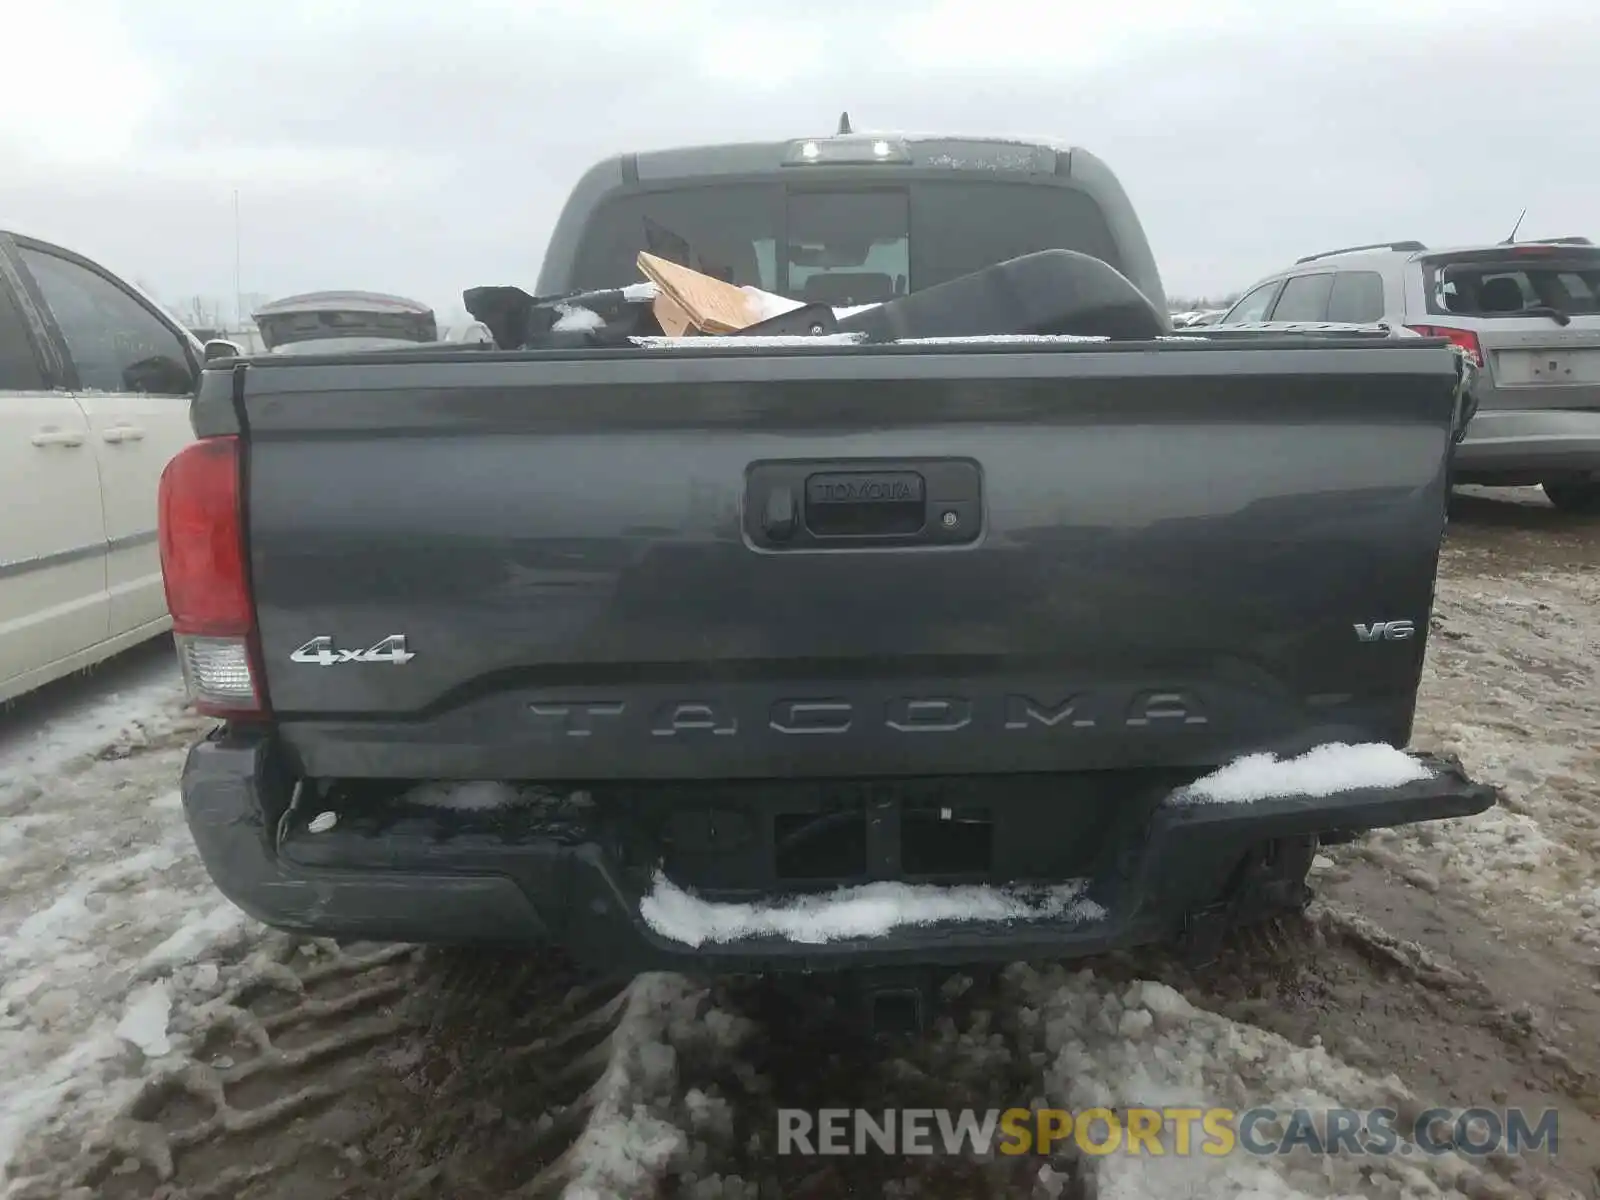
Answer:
[{"left": 238, "top": 339, "right": 1456, "bottom": 779}]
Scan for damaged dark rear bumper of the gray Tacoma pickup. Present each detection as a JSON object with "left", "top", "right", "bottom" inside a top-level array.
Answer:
[{"left": 182, "top": 734, "right": 1496, "bottom": 974}]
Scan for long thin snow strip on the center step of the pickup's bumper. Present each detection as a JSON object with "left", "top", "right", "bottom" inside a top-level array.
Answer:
[{"left": 638, "top": 872, "right": 1106, "bottom": 946}]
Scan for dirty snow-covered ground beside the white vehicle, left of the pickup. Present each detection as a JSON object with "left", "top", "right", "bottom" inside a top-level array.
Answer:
[{"left": 0, "top": 654, "right": 246, "bottom": 1186}]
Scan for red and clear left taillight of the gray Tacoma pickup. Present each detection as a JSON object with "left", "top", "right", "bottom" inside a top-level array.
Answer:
[{"left": 157, "top": 437, "right": 266, "bottom": 717}]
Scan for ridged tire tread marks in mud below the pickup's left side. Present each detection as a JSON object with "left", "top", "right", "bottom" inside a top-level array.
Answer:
[{"left": 16, "top": 938, "right": 624, "bottom": 1200}]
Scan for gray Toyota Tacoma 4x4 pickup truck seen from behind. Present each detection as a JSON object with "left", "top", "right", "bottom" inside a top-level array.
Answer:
[{"left": 162, "top": 138, "right": 1494, "bottom": 998}]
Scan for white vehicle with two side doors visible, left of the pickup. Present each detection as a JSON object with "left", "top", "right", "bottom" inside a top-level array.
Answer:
[{"left": 0, "top": 230, "right": 205, "bottom": 704}]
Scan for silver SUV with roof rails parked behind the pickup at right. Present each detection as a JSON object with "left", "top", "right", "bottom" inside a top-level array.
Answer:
[{"left": 1219, "top": 237, "right": 1600, "bottom": 512}]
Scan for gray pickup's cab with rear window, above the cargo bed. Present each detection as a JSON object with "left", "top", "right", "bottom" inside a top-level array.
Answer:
[{"left": 538, "top": 133, "right": 1166, "bottom": 312}]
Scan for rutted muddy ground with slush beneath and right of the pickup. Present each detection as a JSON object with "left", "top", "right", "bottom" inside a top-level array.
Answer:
[{"left": 0, "top": 491, "right": 1600, "bottom": 1200}]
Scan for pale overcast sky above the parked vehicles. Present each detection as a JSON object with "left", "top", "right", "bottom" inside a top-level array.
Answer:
[{"left": 0, "top": 0, "right": 1600, "bottom": 315}]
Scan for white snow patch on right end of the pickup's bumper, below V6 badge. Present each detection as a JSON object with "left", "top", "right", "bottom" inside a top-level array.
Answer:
[{"left": 1168, "top": 742, "right": 1434, "bottom": 805}]
